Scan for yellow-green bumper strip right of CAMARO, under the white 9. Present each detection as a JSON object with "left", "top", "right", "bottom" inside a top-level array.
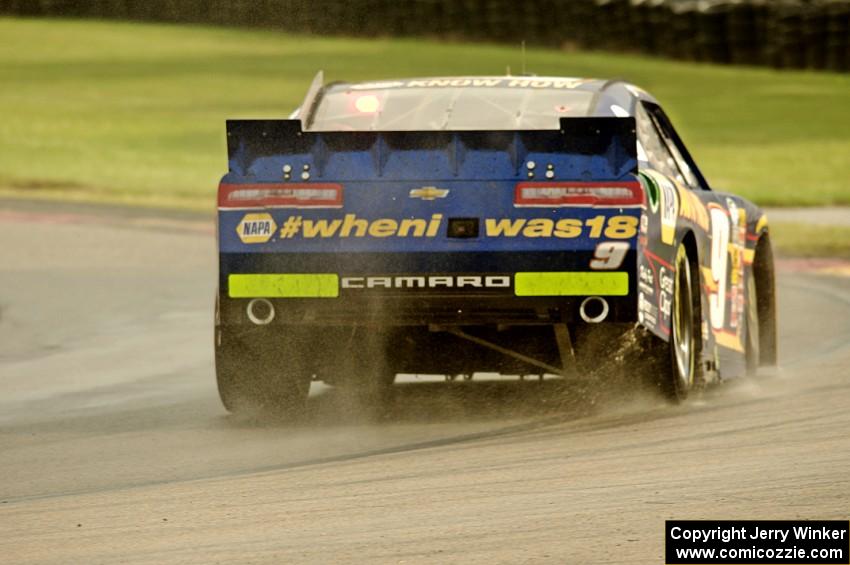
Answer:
[{"left": 514, "top": 271, "right": 629, "bottom": 296}]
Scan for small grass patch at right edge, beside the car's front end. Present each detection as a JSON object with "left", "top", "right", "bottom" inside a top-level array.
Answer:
[{"left": 770, "top": 222, "right": 850, "bottom": 259}]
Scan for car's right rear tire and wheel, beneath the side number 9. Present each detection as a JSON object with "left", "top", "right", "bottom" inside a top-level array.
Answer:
[{"left": 658, "top": 243, "right": 702, "bottom": 402}]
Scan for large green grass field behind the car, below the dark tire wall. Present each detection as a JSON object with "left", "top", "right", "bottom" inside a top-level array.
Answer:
[{"left": 0, "top": 19, "right": 850, "bottom": 207}]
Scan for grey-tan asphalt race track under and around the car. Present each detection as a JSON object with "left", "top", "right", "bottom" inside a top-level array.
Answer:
[{"left": 0, "top": 202, "right": 850, "bottom": 564}]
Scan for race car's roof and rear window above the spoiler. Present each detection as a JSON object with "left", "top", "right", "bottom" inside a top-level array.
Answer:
[{"left": 302, "top": 76, "right": 654, "bottom": 131}]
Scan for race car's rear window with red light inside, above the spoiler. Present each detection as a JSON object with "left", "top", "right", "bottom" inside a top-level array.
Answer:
[{"left": 307, "top": 85, "right": 593, "bottom": 131}]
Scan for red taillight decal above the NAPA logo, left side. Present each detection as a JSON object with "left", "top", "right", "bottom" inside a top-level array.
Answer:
[{"left": 218, "top": 183, "right": 343, "bottom": 209}]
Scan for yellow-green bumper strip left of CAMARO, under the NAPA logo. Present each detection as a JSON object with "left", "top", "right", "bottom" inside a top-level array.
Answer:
[{"left": 232, "top": 273, "right": 339, "bottom": 298}]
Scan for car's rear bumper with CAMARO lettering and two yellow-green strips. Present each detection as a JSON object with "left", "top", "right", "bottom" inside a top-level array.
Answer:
[{"left": 219, "top": 252, "right": 637, "bottom": 326}]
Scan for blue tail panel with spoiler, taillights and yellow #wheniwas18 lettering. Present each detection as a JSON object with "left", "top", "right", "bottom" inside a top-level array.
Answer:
[{"left": 219, "top": 118, "right": 642, "bottom": 253}]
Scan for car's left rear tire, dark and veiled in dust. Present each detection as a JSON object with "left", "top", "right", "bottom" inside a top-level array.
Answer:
[{"left": 215, "top": 326, "right": 312, "bottom": 421}]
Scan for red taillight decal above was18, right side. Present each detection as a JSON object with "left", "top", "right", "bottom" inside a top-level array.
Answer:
[{"left": 514, "top": 181, "right": 643, "bottom": 208}]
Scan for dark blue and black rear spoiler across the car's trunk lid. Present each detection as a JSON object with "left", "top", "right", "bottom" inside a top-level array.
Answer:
[{"left": 225, "top": 118, "right": 637, "bottom": 183}]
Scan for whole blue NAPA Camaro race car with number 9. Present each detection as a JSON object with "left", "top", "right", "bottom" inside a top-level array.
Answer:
[{"left": 215, "top": 73, "right": 777, "bottom": 415}]
